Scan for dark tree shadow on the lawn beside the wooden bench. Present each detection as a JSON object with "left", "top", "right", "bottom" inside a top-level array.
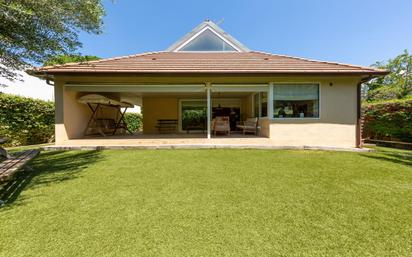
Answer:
[{"left": 0, "top": 151, "right": 100, "bottom": 205}]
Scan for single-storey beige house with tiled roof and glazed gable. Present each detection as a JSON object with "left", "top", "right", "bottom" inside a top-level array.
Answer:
[{"left": 33, "top": 20, "right": 387, "bottom": 147}]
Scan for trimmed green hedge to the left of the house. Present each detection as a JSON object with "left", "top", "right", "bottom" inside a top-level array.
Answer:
[{"left": 0, "top": 93, "right": 54, "bottom": 146}]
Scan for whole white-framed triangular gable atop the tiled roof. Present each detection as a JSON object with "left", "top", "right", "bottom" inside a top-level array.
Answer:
[{"left": 167, "top": 20, "right": 249, "bottom": 52}]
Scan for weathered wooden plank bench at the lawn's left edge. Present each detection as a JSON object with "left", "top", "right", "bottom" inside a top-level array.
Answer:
[{"left": 0, "top": 150, "right": 40, "bottom": 183}]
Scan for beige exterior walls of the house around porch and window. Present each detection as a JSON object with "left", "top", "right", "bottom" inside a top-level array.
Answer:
[{"left": 55, "top": 75, "right": 361, "bottom": 147}]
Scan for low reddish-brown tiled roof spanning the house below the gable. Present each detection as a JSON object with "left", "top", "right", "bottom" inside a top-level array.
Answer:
[{"left": 33, "top": 51, "right": 387, "bottom": 75}]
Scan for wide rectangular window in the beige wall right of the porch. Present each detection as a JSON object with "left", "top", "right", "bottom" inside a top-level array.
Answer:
[{"left": 273, "top": 84, "right": 319, "bottom": 118}]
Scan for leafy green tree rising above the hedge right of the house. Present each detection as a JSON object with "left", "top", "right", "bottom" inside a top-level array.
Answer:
[{"left": 364, "top": 50, "right": 412, "bottom": 101}]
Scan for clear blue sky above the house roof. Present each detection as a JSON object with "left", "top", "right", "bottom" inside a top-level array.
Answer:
[{"left": 80, "top": 0, "right": 412, "bottom": 65}]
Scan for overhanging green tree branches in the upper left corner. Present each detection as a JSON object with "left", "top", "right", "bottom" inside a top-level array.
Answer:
[{"left": 0, "top": 0, "right": 104, "bottom": 80}]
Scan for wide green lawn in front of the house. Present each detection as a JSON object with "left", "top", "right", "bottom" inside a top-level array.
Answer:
[{"left": 0, "top": 148, "right": 412, "bottom": 257}]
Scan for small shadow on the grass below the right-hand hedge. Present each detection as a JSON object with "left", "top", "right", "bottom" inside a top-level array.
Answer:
[{"left": 361, "top": 148, "right": 412, "bottom": 167}]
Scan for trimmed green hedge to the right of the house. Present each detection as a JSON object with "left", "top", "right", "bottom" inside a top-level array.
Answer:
[{"left": 363, "top": 99, "right": 412, "bottom": 142}]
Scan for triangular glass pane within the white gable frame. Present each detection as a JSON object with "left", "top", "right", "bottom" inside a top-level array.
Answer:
[{"left": 178, "top": 29, "right": 238, "bottom": 52}]
